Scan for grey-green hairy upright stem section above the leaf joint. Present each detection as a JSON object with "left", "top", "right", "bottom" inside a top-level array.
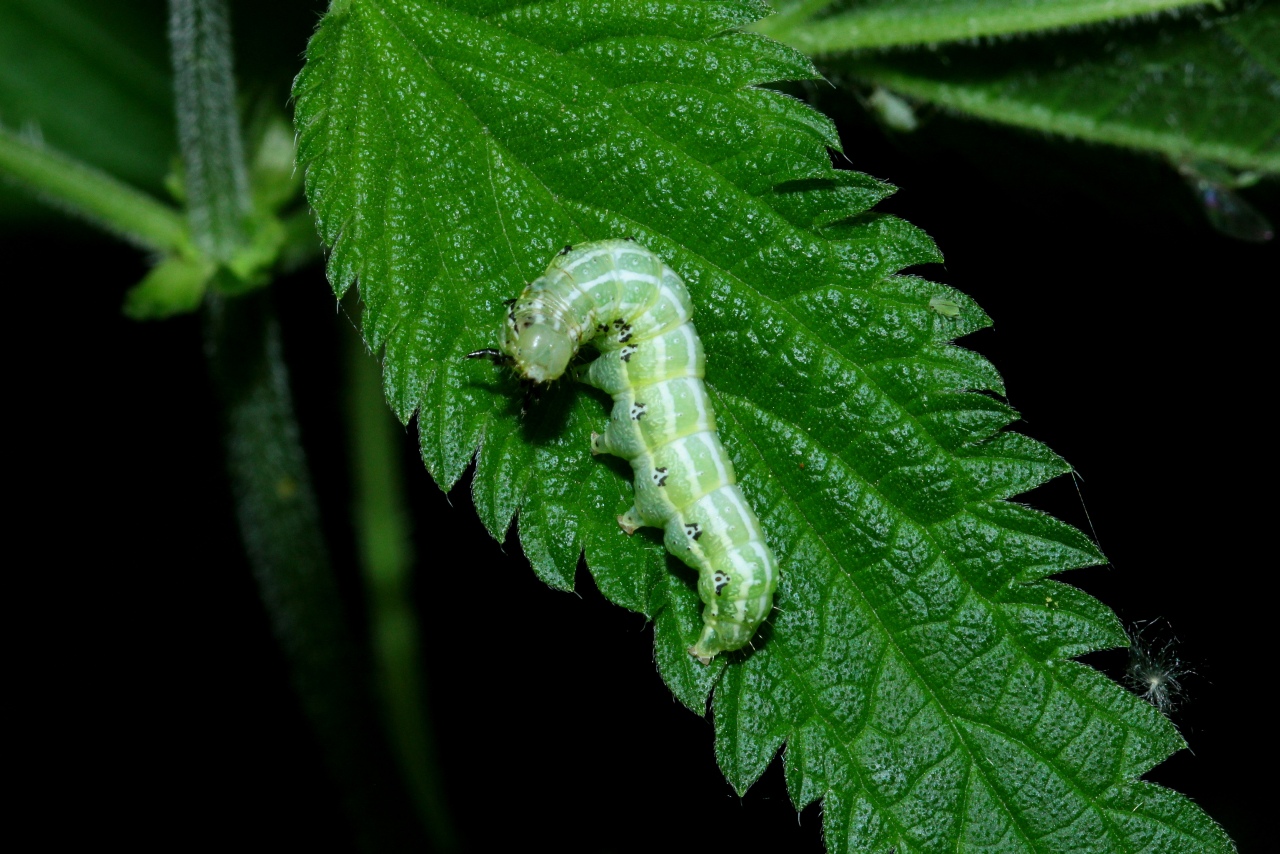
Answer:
[{"left": 169, "top": 0, "right": 251, "bottom": 262}]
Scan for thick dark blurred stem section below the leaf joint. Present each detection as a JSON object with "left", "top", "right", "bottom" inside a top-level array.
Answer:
[{"left": 206, "top": 292, "right": 417, "bottom": 851}]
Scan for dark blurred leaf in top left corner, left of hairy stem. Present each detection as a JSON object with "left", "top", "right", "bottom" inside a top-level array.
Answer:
[{"left": 0, "top": 0, "right": 174, "bottom": 218}]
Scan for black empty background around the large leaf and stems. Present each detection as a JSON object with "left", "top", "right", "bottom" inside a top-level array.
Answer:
[{"left": 0, "top": 16, "right": 1280, "bottom": 851}]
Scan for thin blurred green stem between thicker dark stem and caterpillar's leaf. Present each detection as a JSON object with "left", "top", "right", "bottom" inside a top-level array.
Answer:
[{"left": 346, "top": 334, "right": 457, "bottom": 851}]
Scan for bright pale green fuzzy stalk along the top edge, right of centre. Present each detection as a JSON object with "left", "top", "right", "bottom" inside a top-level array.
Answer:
[{"left": 753, "top": 0, "right": 1207, "bottom": 55}]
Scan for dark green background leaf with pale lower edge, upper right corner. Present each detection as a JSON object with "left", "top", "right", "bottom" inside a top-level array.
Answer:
[{"left": 824, "top": 3, "right": 1280, "bottom": 174}]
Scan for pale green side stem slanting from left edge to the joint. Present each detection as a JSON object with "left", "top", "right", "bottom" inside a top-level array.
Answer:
[{"left": 0, "top": 127, "right": 187, "bottom": 252}]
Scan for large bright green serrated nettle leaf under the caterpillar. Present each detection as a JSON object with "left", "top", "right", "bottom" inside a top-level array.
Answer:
[{"left": 294, "top": 0, "right": 1231, "bottom": 853}]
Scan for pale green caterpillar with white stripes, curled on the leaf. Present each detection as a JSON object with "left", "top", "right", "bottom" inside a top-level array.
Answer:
[{"left": 468, "top": 238, "right": 778, "bottom": 665}]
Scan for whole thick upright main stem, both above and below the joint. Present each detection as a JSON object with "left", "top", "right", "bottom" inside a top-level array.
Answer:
[{"left": 169, "top": 0, "right": 421, "bottom": 853}]
